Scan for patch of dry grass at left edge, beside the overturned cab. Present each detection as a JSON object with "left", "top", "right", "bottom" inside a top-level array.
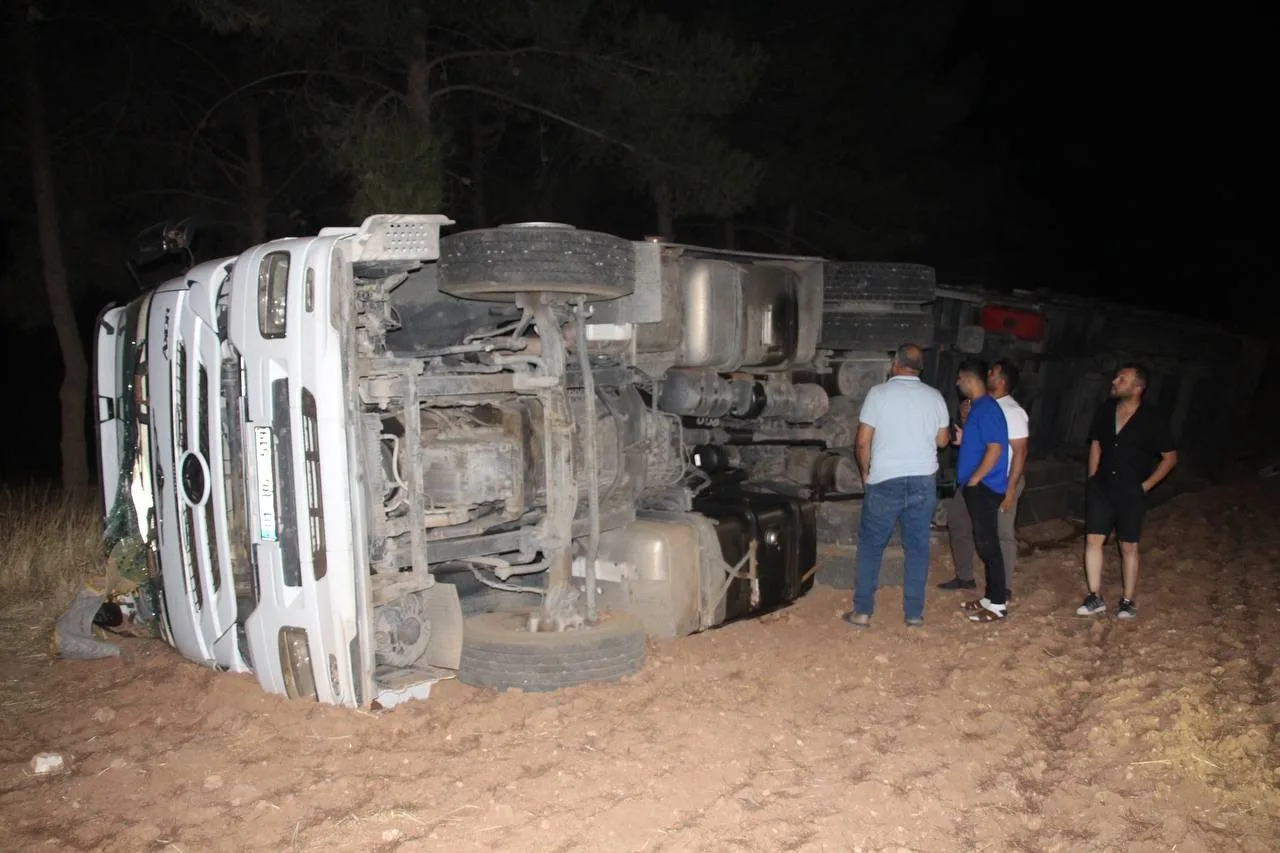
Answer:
[{"left": 0, "top": 485, "right": 104, "bottom": 608}]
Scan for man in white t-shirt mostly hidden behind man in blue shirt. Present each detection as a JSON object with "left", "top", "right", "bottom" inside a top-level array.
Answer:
[{"left": 938, "top": 361, "right": 1030, "bottom": 589}]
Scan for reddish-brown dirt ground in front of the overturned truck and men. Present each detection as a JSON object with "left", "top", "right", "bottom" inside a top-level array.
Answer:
[{"left": 0, "top": 480, "right": 1280, "bottom": 853}]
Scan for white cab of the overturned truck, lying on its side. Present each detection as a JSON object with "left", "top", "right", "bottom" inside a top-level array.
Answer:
[{"left": 97, "top": 216, "right": 461, "bottom": 706}]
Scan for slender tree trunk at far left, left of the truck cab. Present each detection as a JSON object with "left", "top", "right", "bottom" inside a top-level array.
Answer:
[{"left": 18, "top": 24, "right": 90, "bottom": 498}]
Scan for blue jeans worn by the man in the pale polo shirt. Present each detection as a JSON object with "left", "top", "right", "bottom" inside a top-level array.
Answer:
[{"left": 854, "top": 474, "right": 938, "bottom": 619}]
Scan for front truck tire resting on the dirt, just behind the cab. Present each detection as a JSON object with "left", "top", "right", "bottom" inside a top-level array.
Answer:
[{"left": 458, "top": 608, "right": 646, "bottom": 693}]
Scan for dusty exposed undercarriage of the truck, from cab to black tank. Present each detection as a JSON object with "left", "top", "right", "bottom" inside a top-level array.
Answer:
[{"left": 349, "top": 224, "right": 859, "bottom": 689}]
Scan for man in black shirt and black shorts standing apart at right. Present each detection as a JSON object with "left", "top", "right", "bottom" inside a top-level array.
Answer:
[{"left": 1075, "top": 364, "right": 1178, "bottom": 619}]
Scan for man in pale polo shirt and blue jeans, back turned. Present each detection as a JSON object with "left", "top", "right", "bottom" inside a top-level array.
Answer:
[{"left": 842, "top": 343, "right": 950, "bottom": 628}]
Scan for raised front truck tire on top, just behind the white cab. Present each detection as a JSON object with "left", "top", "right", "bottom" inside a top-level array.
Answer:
[{"left": 436, "top": 223, "right": 635, "bottom": 302}]
